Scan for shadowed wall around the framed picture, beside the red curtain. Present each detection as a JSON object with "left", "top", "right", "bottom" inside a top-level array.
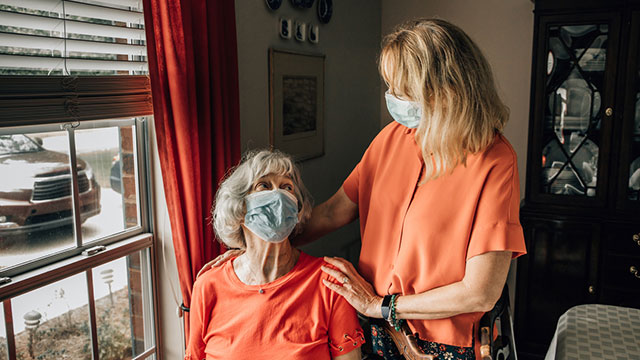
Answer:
[{"left": 235, "top": 0, "right": 381, "bottom": 260}]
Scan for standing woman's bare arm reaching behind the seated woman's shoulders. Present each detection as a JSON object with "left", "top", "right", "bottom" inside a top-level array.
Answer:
[{"left": 291, "top": 187, "right": 358, "bottom": 246}]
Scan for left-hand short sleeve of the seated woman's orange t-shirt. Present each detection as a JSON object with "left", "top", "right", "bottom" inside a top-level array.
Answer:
[{"left": 184, "top": 278, "right": 209, "bottom": 360}]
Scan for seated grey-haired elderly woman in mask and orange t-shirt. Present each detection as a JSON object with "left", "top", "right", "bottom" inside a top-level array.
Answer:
[{"left": 185, "top": 150, "right": 364, "bottom": 360}]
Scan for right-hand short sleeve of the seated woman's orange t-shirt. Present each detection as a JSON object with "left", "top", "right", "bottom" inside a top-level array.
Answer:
[{"left": 329, "top": 268, "right": 365, "bottom": 357}]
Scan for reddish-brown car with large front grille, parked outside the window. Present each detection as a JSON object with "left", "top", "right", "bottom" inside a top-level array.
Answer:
[{"left": 0, "top": 134, "right": 101, "bottom": 235}]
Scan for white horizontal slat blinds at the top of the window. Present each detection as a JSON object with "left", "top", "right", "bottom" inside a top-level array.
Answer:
[{"left": 0, "top": 0, "right": 148, "bottom": 76}]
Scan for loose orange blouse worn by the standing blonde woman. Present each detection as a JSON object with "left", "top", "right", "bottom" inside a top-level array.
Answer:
[{"left": 343, "top": 122, "right": 526, "bottom": 347}]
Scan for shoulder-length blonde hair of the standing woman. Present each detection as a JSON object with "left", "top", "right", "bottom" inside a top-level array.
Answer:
[{"left": 379, "top": 19, "right": 509, "bottom": 181}]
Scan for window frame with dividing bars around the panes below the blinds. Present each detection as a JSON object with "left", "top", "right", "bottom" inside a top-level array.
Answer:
[{"left": 0, "top": 114, "right": 162, "bottom": 360}]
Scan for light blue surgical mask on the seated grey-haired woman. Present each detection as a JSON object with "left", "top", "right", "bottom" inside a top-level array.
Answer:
[{"left": 244, "top": 189, "right": 298, "bottom": 243}]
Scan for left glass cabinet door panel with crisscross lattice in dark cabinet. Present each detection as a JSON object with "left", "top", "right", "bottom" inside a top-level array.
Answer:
[{"left": 539, "top": 22, "right": 612, "bottom": 198}]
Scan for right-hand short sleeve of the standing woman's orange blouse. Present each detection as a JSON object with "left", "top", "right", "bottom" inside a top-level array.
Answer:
[{"left": 467, "top": 144, "right": 527, "bottom": 260}]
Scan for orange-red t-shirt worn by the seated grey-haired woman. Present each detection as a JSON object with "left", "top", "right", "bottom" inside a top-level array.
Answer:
[{"left": 185, "top": 253, "right": 364, "bottom": 360}]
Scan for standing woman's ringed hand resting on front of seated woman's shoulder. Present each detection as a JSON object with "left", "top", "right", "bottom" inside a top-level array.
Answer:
[{"left": 322, "top": 256, "right": 382, "bottom": 318}]
